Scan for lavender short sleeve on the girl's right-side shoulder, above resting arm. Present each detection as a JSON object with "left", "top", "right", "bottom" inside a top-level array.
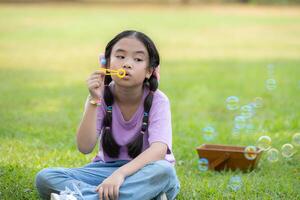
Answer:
[{"left": 148, "top": 98, "right": 172, "bottom": 154}]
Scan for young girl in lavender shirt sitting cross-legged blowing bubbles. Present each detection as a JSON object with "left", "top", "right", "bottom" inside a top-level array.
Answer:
[{"left": 36, "top": 31, "right": 180, "bottom": 200}]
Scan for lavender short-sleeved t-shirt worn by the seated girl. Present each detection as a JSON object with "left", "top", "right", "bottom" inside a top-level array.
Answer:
[{"left": 93, "top": 82, "right": 175, "bottom": 164}]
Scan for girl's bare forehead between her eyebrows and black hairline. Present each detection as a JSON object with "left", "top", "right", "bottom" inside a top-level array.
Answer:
[{"left": 112, "top": 37, "right": 148, "bottom": 55}]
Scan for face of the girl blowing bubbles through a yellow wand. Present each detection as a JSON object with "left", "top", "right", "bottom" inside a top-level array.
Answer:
[{"left": 109, "top": 37, "right": 153, "bottom": 87}]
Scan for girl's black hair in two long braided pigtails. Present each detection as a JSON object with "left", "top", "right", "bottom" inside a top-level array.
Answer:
[{"left": 101, "top": 30, "right": 160, "bottom": 158}]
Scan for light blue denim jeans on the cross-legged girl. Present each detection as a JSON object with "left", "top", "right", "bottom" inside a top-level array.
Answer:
[{"left": 35, "top": 160, "right": 180, "bottom": 200}]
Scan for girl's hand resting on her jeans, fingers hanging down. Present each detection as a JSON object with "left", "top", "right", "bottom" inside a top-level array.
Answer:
[{"left": 96, "top": 172, "right": 125, "bottom": 200}]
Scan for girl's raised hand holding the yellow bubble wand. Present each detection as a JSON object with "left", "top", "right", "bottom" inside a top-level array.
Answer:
[{"left": 86, "top": 54, "right": 105, "bottom": 99}]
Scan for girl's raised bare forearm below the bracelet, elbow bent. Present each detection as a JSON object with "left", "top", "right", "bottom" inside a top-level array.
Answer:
[{"left": 77, "top": 96, "right": 98, "bottom": 154}]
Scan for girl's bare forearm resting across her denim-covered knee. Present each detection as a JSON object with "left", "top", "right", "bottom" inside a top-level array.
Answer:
[{"left": 114, "top": 142, "right": 168, "bottom": 177}]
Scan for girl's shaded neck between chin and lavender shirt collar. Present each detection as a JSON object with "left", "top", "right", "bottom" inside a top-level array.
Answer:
[{"left": 114, "top": 84, "right": 143, "bottom": 105}]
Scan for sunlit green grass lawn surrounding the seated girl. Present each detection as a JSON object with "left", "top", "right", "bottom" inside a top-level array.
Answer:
[{"left": 0, "top": 4, "right": 300, "bottom": 199}]
